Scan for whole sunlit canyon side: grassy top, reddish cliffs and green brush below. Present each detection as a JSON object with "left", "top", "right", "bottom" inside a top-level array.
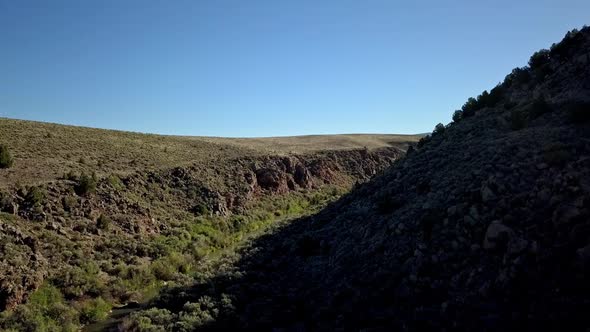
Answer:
[{"left": 0, "top": 120, "right": 412, "bottom": 331}]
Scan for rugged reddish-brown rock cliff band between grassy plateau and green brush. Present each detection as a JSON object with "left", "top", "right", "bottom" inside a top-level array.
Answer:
[{"left": 0, "top": 148, "right": 404, "bottom": 310}]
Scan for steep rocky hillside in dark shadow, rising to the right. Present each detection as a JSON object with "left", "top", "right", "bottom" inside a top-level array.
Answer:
[{"left": 120, "top": 28, "right": 590, "bottom": 331}]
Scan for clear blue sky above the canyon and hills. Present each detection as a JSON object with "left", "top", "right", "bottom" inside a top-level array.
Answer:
[{"left": 0, "top": 0, "right": 590, "bottom": 136}]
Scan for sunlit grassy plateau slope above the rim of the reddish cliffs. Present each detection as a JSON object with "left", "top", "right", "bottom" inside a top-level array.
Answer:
[{"left": 0, "top": 118, "right": 420, "bottom": 188}]
